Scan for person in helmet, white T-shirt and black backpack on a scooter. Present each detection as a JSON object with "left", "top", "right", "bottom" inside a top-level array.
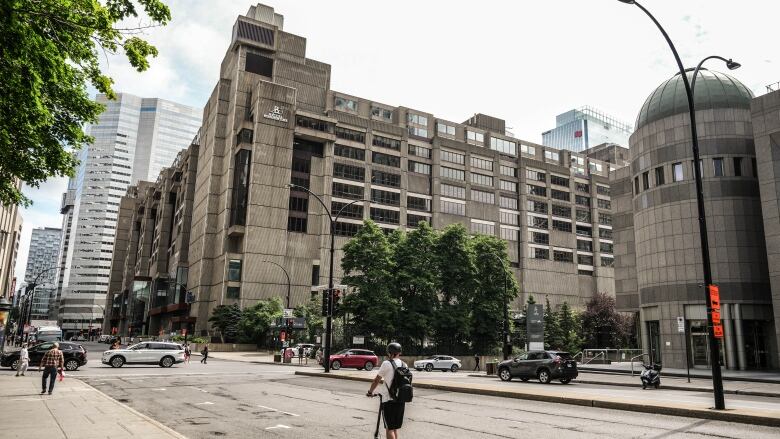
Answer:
[{"left": 366, "top": 343, "right": 411, "bottom": 439}]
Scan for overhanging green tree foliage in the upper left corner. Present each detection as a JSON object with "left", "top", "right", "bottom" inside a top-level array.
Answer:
[{"left": 0, "top": 0, "right": 171, "bottom": 205}]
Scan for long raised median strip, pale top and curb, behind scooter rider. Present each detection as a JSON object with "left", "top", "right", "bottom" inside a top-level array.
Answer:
[{"left": 295, "top": 370, "right": 780, "bottom": 427}]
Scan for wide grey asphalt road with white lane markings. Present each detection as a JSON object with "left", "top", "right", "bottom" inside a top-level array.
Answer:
[{"left": 9, "top": 344, "right": 780, "bottom": 439}]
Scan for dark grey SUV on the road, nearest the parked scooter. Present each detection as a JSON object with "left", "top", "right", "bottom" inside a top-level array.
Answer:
[{"left": 498, "top": 351, "right": 577, "bottom": 384}]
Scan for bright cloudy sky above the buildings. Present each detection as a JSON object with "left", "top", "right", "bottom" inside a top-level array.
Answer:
[{"left": 16, "top": 0, "right": 780, "bottom": 279}]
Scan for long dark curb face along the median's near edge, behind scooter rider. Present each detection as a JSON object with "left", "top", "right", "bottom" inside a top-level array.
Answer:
[{"left": 295, "top": 371, "right": 780, "bottom": 427}]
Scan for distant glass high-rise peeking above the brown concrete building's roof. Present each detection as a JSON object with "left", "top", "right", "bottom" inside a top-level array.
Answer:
[{"left": 542, "top": 106, "right": 633, "bottom": 152}]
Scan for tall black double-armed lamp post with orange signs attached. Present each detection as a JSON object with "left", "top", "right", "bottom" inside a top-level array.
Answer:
[{"left": 618, "top": 0, "right": 740, "bottom": 410}]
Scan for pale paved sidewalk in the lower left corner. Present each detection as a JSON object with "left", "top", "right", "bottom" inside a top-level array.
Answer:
[{"left": 0, "top": 370, "right": 184, "bottom": 439}]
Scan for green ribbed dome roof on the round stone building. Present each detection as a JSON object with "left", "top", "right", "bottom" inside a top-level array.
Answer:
[{"left": 634, "top": 69, "right": 753, "bottom": 130}]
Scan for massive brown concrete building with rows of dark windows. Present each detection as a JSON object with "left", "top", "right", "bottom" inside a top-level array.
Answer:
[{"left": 109, "top": 5, "right": 614, "bottom": 335}]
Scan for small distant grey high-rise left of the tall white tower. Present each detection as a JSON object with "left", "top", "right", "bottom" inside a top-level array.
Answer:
[{"left": 24, "top": 227, "right": 62, "bottom": 320}]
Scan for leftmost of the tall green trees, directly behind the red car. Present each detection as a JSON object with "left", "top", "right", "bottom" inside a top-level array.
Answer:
[{"left": 341, "top": 220, "right": 399, "bottom": 340}]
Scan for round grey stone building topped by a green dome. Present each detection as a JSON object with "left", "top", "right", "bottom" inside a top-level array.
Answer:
[{"left": 611, "top": 70, "right": 780, "bottom": 369}]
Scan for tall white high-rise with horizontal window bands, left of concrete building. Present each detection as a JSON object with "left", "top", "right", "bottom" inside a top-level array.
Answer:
[{"left": 58, "top": 93, "right": 201, "bottom": 335}]
